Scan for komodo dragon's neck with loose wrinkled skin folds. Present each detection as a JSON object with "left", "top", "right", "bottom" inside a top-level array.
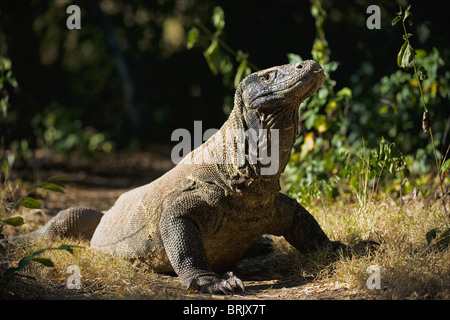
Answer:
[{"left": 218, "top": 99, "right": 298, "bottom": 190}]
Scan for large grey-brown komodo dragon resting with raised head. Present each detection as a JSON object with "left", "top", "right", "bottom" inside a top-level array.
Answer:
[{"left": 1, "top": 60, "right": 345, "bottom": 294}]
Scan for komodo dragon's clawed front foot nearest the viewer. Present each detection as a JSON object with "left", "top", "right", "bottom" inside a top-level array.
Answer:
[{"left": 186, "top": 271, "right": 244, "bottom": 295}]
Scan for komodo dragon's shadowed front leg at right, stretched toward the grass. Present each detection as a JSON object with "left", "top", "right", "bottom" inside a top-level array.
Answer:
[{"left": 278, "top": 193, "right": 346, "bottom": 253}]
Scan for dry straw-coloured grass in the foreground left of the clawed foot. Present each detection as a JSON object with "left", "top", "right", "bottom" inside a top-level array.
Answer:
[{"left": 0, "top": 239, "right": 184, "bottom": 299}]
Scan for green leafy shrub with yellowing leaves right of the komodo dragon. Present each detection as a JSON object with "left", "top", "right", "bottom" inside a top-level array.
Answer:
[{"left": 284, "top": 2, "right": 450, "bottom": 206}]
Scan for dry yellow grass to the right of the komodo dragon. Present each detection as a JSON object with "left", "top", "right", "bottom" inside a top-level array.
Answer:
[{"left": 279, "top": 199, "right": 450, "bottom": 299}]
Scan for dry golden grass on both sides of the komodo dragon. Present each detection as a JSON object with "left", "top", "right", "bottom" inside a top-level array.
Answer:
[{"left": 0, "top": 198, "right": 450, "bottom": 299}]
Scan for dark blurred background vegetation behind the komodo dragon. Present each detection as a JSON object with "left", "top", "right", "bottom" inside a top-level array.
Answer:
[{"left": 0, "top": 0, "right": 450, "bottom": 202}]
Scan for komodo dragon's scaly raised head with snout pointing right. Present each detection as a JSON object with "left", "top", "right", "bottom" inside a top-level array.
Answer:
[{"left": 237, "top": 60, "right": 325, "bottom": 113}]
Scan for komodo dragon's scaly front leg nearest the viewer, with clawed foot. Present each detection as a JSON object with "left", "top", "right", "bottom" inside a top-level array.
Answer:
[{"left": 159, "top": 201, "right": 244, "bottom": 294}]
